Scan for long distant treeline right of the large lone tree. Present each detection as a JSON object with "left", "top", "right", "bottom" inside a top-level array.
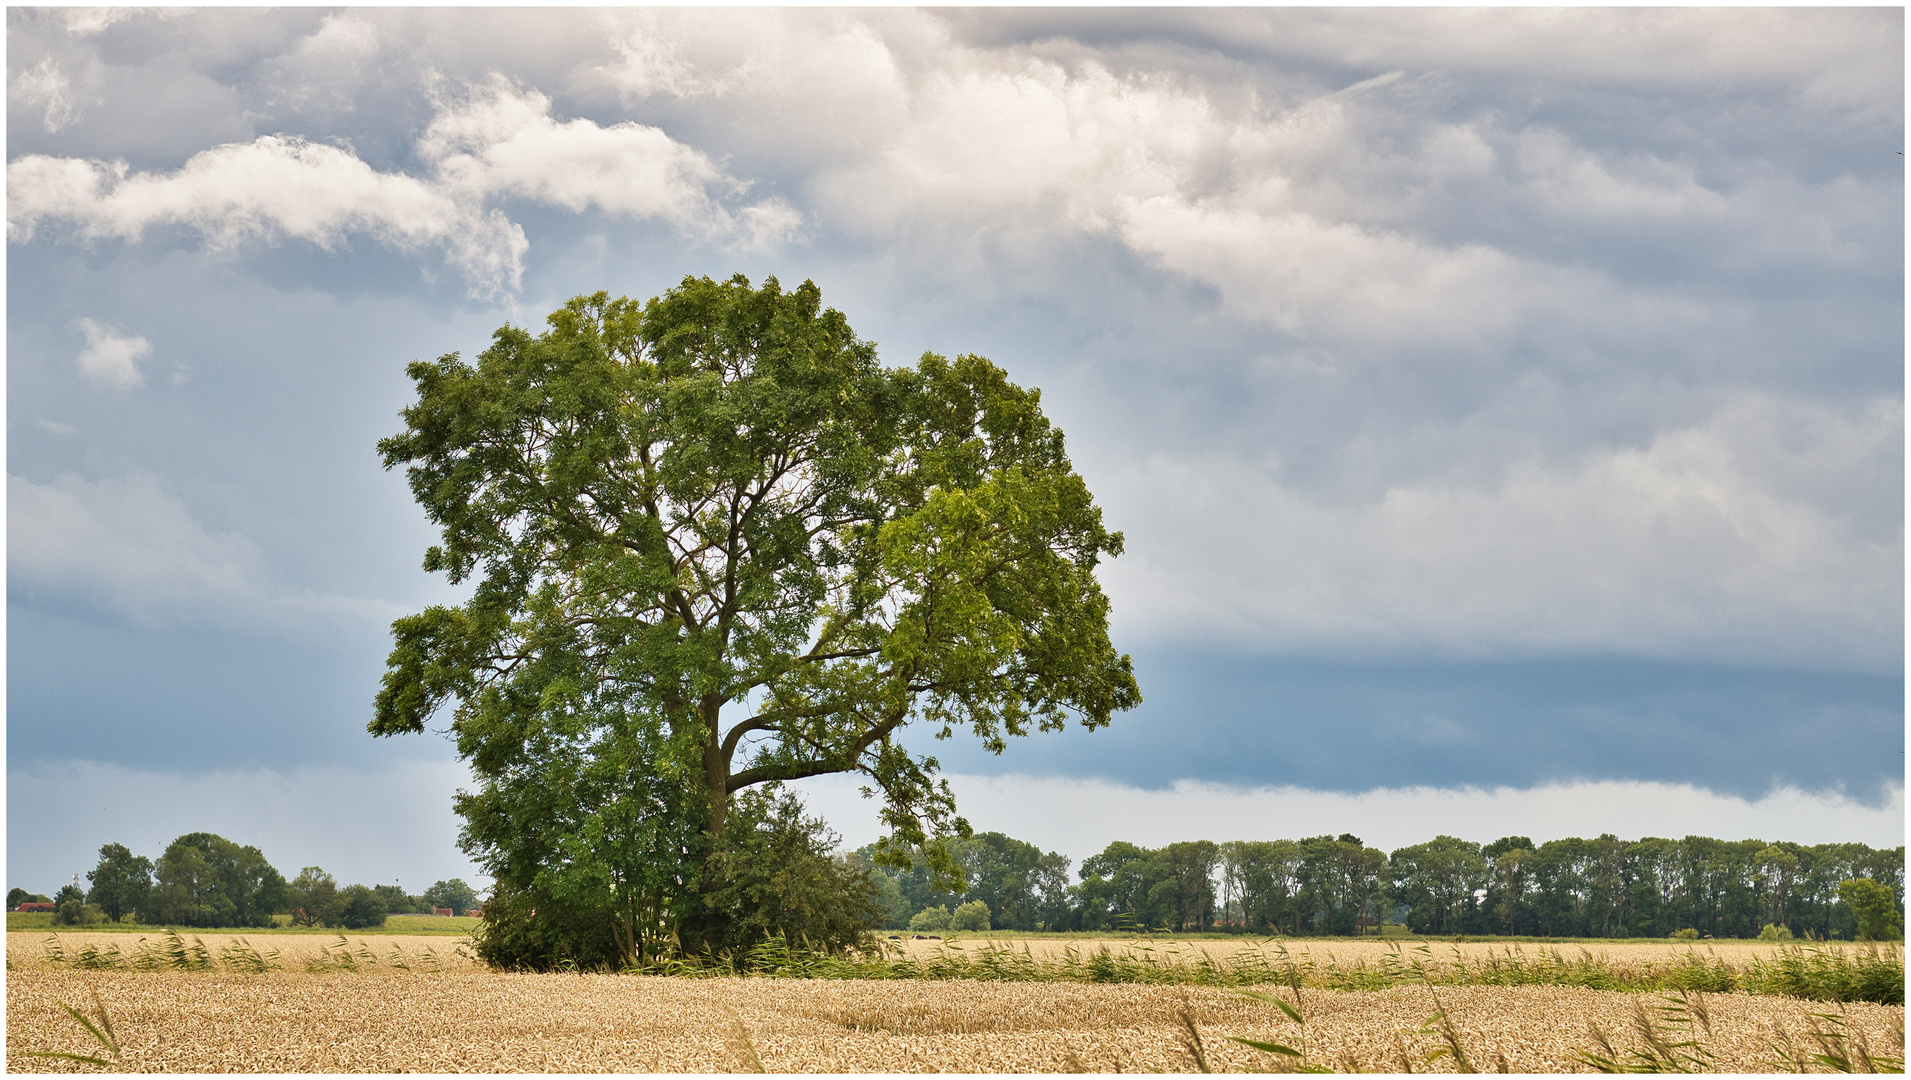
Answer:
[{"left": 850, "top": 833, "right": 1905, "bottom": 939}]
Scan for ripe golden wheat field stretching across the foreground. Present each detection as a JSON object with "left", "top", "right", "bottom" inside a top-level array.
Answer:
[{"left": 6, "top": 935, "right": 1903, "bottom": 1072}]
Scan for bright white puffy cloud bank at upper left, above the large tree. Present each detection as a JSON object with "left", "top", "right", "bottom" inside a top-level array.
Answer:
[{"left": 8, "top": 78, "right": 801, "bottom": 296}]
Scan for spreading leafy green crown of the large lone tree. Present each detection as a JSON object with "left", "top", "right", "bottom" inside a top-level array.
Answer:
[{"left": 369, "top": 277, "right": 1141, "bottom": 951}]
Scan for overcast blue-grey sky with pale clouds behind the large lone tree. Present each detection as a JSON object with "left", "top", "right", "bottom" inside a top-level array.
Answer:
[{"left": 6, "top": 8, "right": 1905, "bottom": 891}]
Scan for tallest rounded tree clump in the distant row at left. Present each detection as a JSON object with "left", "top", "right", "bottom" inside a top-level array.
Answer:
[{"left": 140, "top": 833, "right": 289, "bottom": 927}]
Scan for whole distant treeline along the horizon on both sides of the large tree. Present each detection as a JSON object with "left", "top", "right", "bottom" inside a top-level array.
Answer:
[{"left": 8, "top": 822, "right": 1905, "bottom": 940}]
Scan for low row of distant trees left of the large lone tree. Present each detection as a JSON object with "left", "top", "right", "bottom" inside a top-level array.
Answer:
[{"left": 6, "top": 833, "right": 478, "bottom": 929}]
